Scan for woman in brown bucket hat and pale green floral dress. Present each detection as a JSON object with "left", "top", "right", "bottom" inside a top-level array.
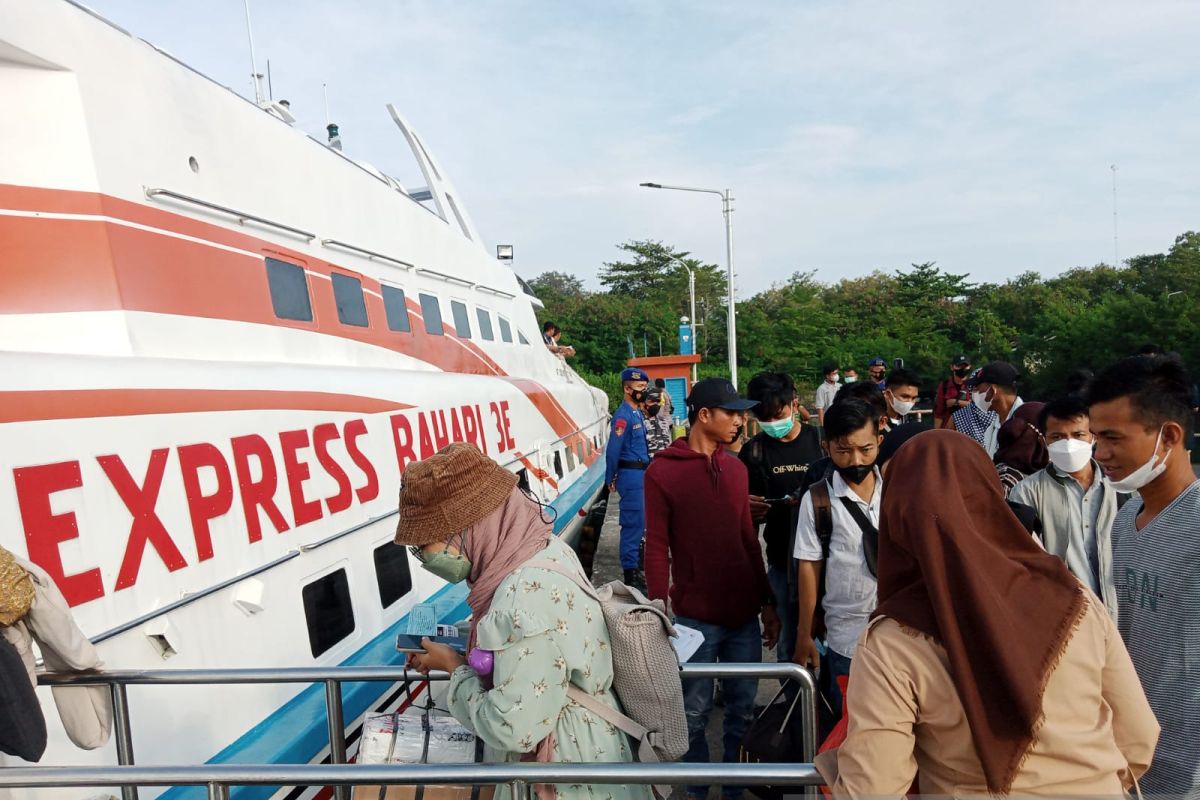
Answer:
[{"left": 396, "top": 443, "right": 650, "bottom": 800}]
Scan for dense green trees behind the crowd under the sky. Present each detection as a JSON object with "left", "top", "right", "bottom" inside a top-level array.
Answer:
[{"left": 530, "top": 231, "right": 1200, "bottom": 404}]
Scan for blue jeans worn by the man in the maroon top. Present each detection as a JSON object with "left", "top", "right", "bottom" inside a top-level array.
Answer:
[{"left": 677, "top": 616, "right": 762, "bottom": 798}]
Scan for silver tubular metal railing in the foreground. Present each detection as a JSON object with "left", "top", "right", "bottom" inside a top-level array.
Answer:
[{"left": 23, "top": 663, "right": 822, "bottom": 800}]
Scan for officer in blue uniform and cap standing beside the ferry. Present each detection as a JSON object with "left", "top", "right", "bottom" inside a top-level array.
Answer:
[{"left": 605, "top": 367, "right": 650, "bottom": 591}]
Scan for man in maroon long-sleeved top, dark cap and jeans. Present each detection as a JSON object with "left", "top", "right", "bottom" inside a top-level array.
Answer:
[{"left": 646, "top": 378, "right": 779, "bottom": 798}]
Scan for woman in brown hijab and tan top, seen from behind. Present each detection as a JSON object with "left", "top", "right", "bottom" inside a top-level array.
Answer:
[{"left": 818, "top": 431, "right": 1158, "bottom": 796}]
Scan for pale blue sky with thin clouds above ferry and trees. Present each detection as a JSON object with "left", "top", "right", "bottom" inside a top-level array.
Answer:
[{"left": 82, "top": 0, "right": 1200, "bottom": 297}]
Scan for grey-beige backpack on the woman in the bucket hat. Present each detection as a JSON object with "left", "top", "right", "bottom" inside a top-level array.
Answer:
[{"left": 524, "top": 560, "right": 688, "bottom": 762}]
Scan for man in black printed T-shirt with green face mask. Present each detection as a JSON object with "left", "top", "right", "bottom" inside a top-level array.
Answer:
[{"left": 738, "top": 372, "right": 822, "bottom": 661}]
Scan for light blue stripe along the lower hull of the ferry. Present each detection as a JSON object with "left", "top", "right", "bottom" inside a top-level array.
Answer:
[{"left": 162, "top": 458, "right": 605, "bottom": 800}]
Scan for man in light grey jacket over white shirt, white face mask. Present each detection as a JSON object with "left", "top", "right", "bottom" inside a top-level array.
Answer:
[{"left": 1008, "top": 395, "right": 1128, "bottom": 616}]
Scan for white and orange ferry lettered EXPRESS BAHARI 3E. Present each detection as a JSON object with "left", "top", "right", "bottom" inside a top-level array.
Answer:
[{"left": 0, "top": 0, "right": 608, "bottom": 799}]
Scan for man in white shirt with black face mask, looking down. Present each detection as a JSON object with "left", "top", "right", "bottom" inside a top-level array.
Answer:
[{"left": 793, "top": 399, "right": 883, "bottom": 718}]
